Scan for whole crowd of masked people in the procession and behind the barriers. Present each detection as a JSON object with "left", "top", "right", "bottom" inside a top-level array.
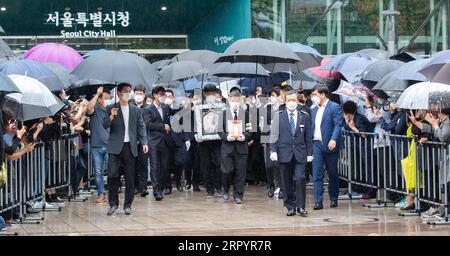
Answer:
[{"left": 0, "top": 78, "right": 450, "bottom": 230}]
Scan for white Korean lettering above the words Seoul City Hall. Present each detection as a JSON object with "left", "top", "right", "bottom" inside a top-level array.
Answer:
[{"left": 45, "top": 11, "right": 130, "bottom": 28}]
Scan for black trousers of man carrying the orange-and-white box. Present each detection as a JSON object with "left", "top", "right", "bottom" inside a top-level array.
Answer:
[{"left": 221, "top": 150, "right": 248, "bottom": 199}]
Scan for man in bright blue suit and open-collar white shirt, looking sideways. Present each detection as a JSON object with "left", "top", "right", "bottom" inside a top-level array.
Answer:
[{"left": 311, "top": 85, "right": 343, "bottom": 210}]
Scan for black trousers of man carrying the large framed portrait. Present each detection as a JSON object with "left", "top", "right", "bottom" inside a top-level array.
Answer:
[{"left": 199, "top": 141, "right": 222, "bottom": 192}]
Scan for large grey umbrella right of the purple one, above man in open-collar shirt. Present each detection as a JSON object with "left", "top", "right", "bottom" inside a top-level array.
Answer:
[{"left": 70, "top": 51, "right": 160, "bottom": 93}]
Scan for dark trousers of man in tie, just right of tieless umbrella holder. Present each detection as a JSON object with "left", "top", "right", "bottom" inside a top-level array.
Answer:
[{"left": 150, "top": 144, "right": 170, "bottom": 195}]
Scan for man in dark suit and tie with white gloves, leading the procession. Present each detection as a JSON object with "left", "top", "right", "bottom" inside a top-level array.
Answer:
[{"left": 270, "top": 91, "right": 313, "bottom": 217}]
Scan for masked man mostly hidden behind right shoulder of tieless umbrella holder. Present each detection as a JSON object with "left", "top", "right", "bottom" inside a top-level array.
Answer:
[{"left": 133, "top": 85, "right": 148, "bottom": 197}]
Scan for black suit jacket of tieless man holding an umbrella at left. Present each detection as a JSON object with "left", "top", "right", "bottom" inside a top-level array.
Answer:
[{"left": 103, "top": 103, "right": 148, "bottom": 157}]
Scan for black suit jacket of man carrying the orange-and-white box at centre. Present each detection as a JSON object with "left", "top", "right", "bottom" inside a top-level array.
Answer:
[{"left": 219, "top": 108, "right": 252, "bottom": 155}]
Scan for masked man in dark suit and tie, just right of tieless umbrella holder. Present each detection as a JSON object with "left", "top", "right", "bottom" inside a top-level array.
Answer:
[{"left": 143, "top": 86, "right": 171, "bottom": 201}]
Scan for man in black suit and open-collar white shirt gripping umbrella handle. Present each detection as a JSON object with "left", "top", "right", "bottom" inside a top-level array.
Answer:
[{"left": 103, "top": 83, "right": 148, "bottom": 215}]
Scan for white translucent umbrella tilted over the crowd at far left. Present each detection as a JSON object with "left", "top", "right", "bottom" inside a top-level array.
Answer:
[{"left": 4, "top": 75, "right": 64, "bottom": 121}]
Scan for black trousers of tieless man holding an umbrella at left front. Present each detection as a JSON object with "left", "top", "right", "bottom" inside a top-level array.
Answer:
[{"left": 108, "top": 143, "right": 136, "bottom": 207}]
